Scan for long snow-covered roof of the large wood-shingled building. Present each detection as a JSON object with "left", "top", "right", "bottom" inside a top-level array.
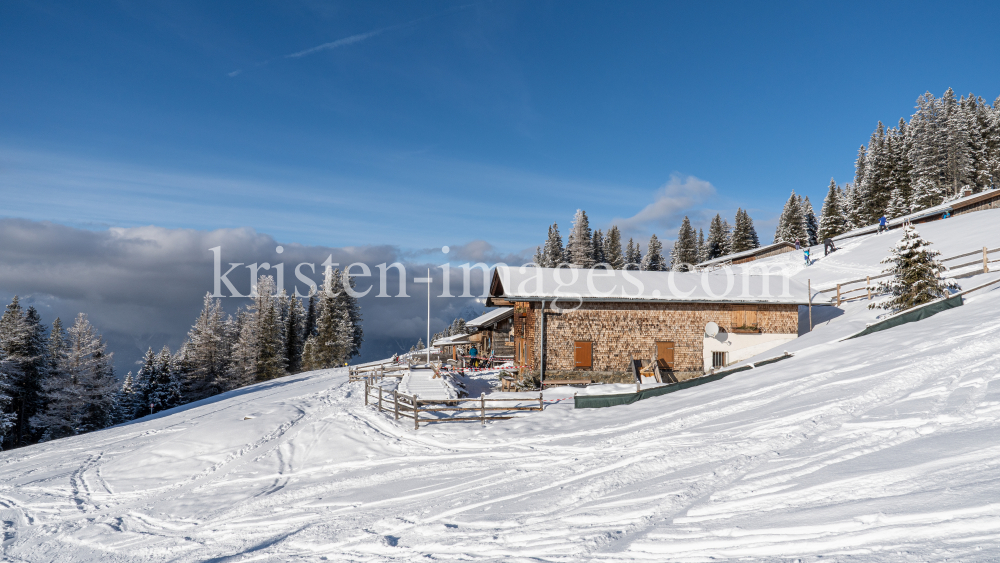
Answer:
[{"left": 490, "top": 266, "right": 832, "bottom": 307}]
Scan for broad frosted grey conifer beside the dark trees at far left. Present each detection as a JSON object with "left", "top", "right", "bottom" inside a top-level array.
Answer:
[{"left": 32, "top": 313, "right": 118, "bottom": 441}]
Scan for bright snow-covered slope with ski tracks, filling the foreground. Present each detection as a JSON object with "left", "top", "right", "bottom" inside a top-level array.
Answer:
[{"left": 0, "top": 212, "right": 1000, "bottom": 561}]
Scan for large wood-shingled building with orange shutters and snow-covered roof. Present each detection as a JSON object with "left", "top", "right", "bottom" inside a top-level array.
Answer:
[{"left": 487, "top": 267, "right": 830, "bottom": 382}]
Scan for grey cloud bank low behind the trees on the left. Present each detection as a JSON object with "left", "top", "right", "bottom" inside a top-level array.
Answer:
[{"left": 0, "top": 219, "right": 499, "bottom": 374}]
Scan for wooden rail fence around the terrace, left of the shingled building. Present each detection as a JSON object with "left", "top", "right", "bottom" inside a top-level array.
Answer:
[{"left": 364, "top": 377, "right": 545, "bottom": 430}]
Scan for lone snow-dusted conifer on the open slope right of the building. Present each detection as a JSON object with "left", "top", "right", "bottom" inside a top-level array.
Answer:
[{"left": 868, "top": 224, "right": 958, "bottom": 312}]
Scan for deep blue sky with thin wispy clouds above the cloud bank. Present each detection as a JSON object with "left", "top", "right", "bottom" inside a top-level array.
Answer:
[{"left": 0, "top": 1, "right": 1000, "bottom": 253}]
